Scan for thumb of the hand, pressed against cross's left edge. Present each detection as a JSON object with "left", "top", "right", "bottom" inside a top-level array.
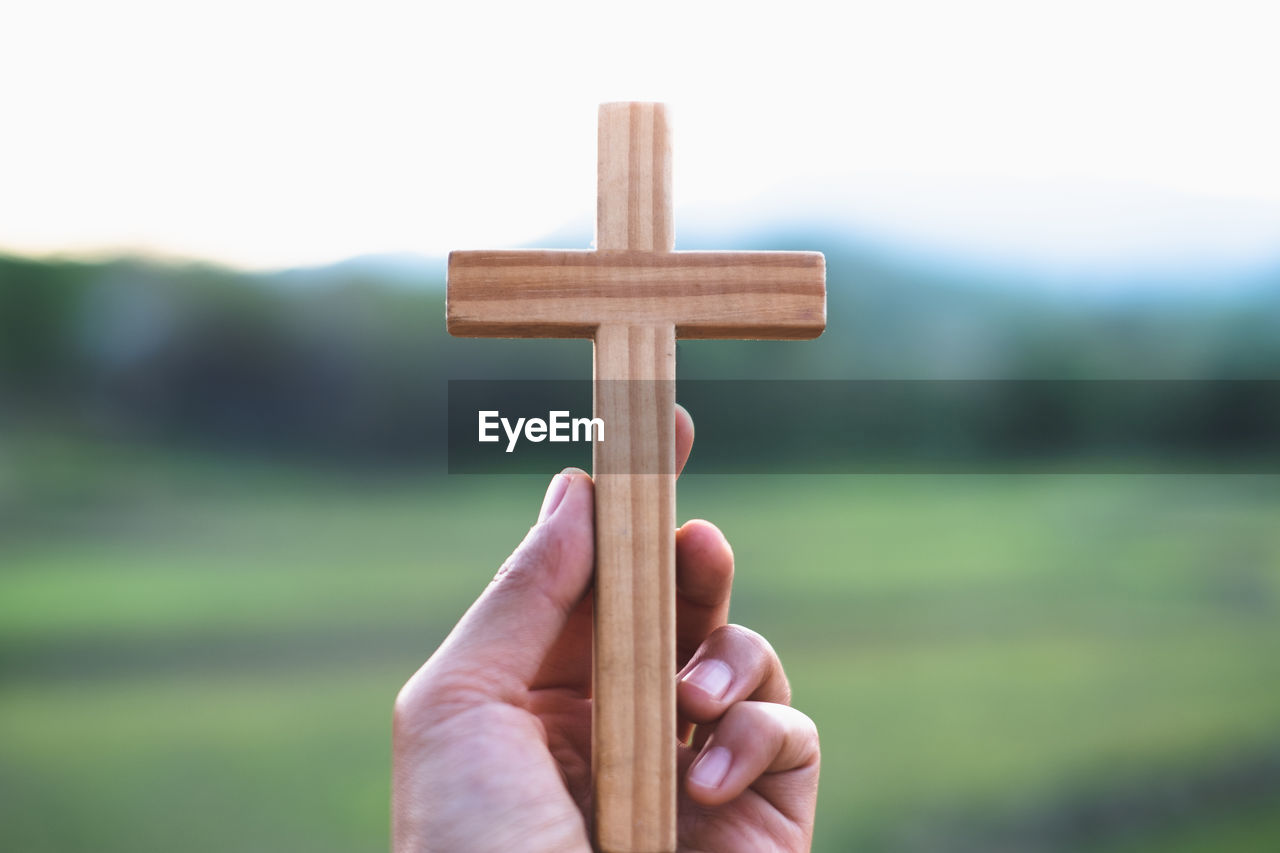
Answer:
[{"left": 428, "top": 467, "right": 595, "bottom": 701}]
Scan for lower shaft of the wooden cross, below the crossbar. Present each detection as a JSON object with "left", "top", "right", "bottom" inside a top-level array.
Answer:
[{"left": 591, "top": 324, "right": 677, "bottom": 853}]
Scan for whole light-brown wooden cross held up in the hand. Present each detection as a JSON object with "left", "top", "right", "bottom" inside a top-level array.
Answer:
[{"left": 447, "top": 102, "right": 827, "bottom": 852}]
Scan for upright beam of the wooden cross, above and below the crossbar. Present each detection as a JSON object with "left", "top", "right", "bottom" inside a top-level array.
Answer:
[{"left": 591, "top": 104, "right": 676, "bottom": 853}]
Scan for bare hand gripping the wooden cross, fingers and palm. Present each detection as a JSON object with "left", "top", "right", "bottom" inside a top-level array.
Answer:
[{"left": 392, "top": 409, "right": 819, "bottom": 853}]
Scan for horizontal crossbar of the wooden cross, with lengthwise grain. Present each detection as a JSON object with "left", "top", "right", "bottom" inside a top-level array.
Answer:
[{"left": 447, "top": 251, "right": 827, "bottom": 341}]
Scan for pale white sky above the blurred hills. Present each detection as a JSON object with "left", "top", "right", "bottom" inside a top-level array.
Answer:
[{"left": 0, "top": 0, "right": 1280, "bottom": 269}]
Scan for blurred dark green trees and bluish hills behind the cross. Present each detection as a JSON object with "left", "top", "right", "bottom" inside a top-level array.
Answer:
[{"left": 0, "top": 233, "right": 1280, "bottom": 464}]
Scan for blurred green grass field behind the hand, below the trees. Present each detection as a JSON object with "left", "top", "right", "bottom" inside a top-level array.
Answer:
[{"left": 0, "top": 435, "right": 1280, "bottom": 853}]
